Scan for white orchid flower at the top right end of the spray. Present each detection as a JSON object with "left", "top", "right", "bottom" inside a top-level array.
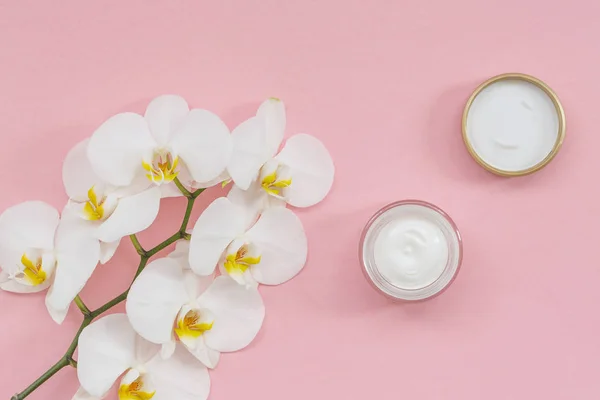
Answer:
[{"left": 227, "top": 98, "right": 335, "bottom": 217}]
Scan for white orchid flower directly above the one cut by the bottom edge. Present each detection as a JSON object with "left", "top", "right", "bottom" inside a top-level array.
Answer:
[{"left": 126, "top": 243, "right": 265, "bottom": 368}]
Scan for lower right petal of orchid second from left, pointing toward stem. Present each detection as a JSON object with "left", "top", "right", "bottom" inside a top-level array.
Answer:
[{"left": 97, "top": 186, "right": 160, "bottom": 242}]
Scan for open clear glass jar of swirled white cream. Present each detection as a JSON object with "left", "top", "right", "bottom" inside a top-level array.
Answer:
[{"left": 359, "top": 200, "right": 462, "bottom": 301}]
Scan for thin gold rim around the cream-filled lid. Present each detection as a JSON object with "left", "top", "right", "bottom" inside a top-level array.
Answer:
[{"left": 462, "top": 73, "right": 566, "bottom": 176}]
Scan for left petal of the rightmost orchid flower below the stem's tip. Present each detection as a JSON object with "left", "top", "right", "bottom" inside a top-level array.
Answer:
[{"left": 189, "top": 197, "right": 247, "bottom": 275}]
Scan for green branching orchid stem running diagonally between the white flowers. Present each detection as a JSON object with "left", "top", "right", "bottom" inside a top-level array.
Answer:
[{"left": 11, "top": 184, "right": 204, "bottom": 400}]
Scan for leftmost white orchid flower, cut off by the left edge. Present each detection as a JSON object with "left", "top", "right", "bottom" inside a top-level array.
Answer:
[{"left": 0, "top": 201, "right": 100, "bottom": 323}]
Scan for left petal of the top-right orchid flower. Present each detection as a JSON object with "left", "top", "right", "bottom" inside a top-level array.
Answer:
[{"left": 227, "top": 117, "right": 269, "bottom": 190}]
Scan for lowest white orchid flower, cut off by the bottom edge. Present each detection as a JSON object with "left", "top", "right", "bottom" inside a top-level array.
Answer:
[{"left": 74, "top": 314, "right": 210, "bottom": 400}]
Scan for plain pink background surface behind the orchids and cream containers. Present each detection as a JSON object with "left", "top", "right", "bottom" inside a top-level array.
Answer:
[{"left": 0, "top": 0, "right": 600, "bottom": 400}]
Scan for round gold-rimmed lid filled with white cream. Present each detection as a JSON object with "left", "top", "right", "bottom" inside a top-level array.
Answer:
[{"left": 462, "top": 73, "right": 565, "bottom": 176}]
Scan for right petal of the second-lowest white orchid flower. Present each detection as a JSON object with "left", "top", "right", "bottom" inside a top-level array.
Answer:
[{"left": 198, "top": 276, "right": 265, "bottom": 352}]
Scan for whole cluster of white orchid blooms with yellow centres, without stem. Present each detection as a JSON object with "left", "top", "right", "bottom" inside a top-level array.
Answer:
[{"left": 0, "top": 95, "right": 334, "bottom": 400}]
